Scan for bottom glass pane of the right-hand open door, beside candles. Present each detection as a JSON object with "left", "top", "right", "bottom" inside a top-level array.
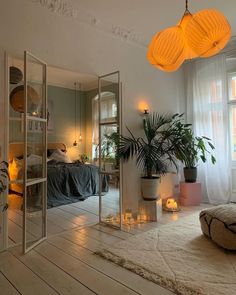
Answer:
[{"left": 101, "top": 170, "right": 120, "bottom": 226}]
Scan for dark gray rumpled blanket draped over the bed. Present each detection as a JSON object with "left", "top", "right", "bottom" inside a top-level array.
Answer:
[{"left": 28, "top": 161, "right": 109, "bottom": 208}]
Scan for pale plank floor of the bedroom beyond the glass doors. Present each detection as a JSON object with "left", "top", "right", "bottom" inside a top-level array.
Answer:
[{"left": 8, "top": 188, "right": 119, "bottom": 246}]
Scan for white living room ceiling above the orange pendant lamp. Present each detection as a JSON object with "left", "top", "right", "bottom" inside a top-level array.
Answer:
[{"left": 70, "top": 0, "right": 236, "bottom": 43}]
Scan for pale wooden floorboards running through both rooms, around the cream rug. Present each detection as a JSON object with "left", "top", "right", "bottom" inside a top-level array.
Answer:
[{"left": 0, "top": 197, "right": 207, "bottom": 295}]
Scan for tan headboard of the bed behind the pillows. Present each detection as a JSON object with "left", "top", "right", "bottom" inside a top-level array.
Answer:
[{"left": 9, "top": 142, "right": 66, "bottom": 162}]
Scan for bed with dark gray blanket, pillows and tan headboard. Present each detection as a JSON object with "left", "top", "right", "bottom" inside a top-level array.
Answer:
[{"left": 9, "top": 143, "right": 108, "bottom": 208}]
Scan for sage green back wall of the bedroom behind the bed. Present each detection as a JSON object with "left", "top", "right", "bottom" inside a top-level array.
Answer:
[{"left": 9, "top": 85, "right": 86, "bottom": 159}]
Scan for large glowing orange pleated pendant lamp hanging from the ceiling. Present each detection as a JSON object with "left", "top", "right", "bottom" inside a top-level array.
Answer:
[{"left": 147, "top": 0, "right": 231, "bottom": 72}]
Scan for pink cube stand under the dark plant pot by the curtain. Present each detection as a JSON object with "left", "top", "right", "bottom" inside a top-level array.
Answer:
[{"left": 180, "top": 182, "right": 202, "bottom": 206}]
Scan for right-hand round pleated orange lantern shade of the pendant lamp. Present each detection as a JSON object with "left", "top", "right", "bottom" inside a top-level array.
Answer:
[{"left": 185, "top": 9, "right": 231, "bottom": 57}]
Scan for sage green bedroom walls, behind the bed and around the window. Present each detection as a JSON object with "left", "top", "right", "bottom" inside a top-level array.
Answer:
[{"left": 9, "top": 84, "right": 118, "bottom": 159}]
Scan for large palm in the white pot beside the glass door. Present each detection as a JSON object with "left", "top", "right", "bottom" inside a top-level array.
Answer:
[{"left": 118, "top": 113, "right": 179, "bottom": 200}]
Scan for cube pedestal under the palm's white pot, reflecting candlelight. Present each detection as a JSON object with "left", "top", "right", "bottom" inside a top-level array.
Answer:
[{"left": 138, "top": 198, "right": 162, "bottom": 221}]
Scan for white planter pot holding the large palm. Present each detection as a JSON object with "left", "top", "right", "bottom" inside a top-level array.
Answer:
[{"left": 141, "top": 178, "right": 160, "bottom": 200}]
